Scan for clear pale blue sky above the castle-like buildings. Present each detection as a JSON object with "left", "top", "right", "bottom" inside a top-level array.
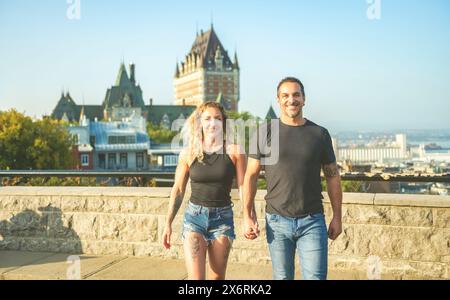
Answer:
[{"left": 0, "top": 0, "right": 450, "bottom": 131}]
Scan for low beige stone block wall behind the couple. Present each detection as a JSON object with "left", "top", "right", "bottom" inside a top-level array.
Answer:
[{"left": 0, "top": 187, "right": 450, "bottom": 279}]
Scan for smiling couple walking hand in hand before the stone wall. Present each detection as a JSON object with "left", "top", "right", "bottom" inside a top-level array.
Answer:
[{"left": 162, "top": 77, "right": 342, "bottom": 280}]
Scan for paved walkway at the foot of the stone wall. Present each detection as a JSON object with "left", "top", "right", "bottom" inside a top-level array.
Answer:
[{"left": 0, "top": 251, "right": 356, "bottom": 280}]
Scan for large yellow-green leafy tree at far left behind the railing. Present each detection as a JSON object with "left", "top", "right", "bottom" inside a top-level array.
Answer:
[{"left": 0, "top": 109, "right": 74, "bottom": 170}]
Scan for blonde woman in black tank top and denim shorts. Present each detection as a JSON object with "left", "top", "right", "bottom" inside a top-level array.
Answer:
[{"left": 162, "top": 102, "right": 246, "bottom": 280}]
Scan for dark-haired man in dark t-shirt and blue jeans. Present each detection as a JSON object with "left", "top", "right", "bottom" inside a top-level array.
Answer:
[{"left": 243, "top": 77, "right": 342, "bottom": 280}]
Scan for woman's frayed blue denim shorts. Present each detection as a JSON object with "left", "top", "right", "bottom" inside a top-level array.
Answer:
[{"left": 181, "top": 201, "right": 236, "bottom": 244}]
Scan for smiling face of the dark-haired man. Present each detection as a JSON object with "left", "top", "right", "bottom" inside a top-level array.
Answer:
[{"left": 277, "top": 82, "right": 305, "bottom": 118}]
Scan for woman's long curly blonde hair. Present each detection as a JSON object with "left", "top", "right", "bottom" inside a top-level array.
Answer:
[{"left": 183, "top": 101, "right": 228, "bottom": 162}]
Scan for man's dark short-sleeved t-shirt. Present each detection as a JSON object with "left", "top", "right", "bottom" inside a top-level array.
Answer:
[{"left": 249, "top": 119, "right": 336, "bottom": 217}]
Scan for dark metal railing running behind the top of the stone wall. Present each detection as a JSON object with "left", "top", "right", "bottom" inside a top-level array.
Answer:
[{"left": 0, "top": 170, "right": 450, "bottom": 183}]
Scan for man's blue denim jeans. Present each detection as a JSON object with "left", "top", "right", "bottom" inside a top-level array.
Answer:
[{"left": 266, "top": 213, "right": 328, "bottom": 280}]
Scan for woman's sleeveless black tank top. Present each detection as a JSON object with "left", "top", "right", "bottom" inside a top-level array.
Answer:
[{"left": 189, "top": 148, "right": 236, "bottom": 207}]
